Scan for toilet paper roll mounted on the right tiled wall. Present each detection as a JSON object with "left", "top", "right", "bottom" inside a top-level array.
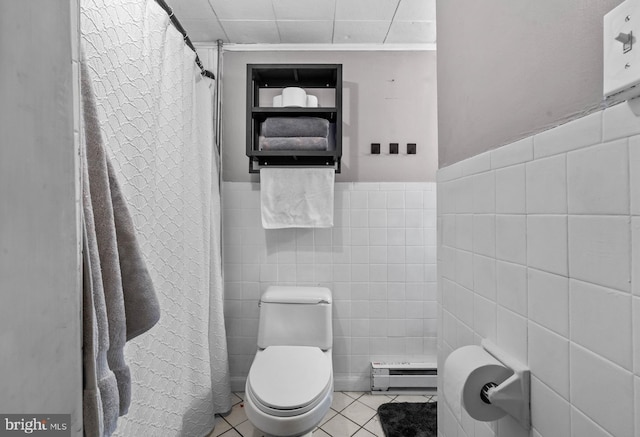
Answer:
[{"left": 442, "top": 346, "right": 513, "bottom": 422}]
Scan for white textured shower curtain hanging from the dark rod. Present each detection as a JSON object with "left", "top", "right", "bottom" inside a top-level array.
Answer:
[{"left": 81, "top": 0, "right": 231, "bottom": 437}]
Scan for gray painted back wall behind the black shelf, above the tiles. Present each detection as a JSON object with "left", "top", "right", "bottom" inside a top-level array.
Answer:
[{"left": 222, "top": 51, "right": 438, "bottom": 182}]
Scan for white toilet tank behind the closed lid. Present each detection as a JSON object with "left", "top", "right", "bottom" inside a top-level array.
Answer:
[{"left": 258, "top": 286, "right": 333, "bottom": 350}]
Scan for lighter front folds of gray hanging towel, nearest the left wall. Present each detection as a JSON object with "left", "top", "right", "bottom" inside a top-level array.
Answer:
[{"left": 81, "top": 58, "right": 124, "bottom": 436}]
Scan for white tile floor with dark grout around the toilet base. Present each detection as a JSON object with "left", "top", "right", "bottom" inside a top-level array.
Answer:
[{"left": 208, "top": 392, "right": 437, "bottom": 437}]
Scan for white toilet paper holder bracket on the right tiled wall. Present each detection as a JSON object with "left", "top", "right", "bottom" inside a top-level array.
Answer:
[{"left": 479, "top": 339, "right": 531, "bottom": 429}]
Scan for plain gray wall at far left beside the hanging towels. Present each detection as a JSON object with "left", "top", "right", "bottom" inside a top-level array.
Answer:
[{"left": 0, "top": 0, "right": 82, "bottom": 436}]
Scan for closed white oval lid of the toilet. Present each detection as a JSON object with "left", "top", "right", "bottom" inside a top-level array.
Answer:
[{"left": 248, "top": 346, "right": 331, "bottom": 410}]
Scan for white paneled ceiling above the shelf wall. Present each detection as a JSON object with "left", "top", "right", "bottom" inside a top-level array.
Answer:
[{"left": 169, "top": 0, "right": 436, "bottom": 44}]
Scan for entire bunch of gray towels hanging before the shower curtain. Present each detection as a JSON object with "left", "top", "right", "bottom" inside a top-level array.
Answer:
[{"left": 80, "top": 52, "right": 160, "bottom": 437}]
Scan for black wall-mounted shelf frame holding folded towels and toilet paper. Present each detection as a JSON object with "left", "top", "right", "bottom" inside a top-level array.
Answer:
[{"left": 247, "top": 64, "right": 342, "bottom": 173}]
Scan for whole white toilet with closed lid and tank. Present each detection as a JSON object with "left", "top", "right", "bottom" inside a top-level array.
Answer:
[{"left": 245, "top": 286, "right": 333, "bottom": 437}]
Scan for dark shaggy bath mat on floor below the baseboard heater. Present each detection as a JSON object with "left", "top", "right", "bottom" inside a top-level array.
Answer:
[{"left": 378, "top": 402, "right": 438, "bottom": 437}]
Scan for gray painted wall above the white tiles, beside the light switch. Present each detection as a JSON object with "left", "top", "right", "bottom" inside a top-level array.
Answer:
[{"left": 437, "top": 0, "right": 621, "bottom": 167}]
